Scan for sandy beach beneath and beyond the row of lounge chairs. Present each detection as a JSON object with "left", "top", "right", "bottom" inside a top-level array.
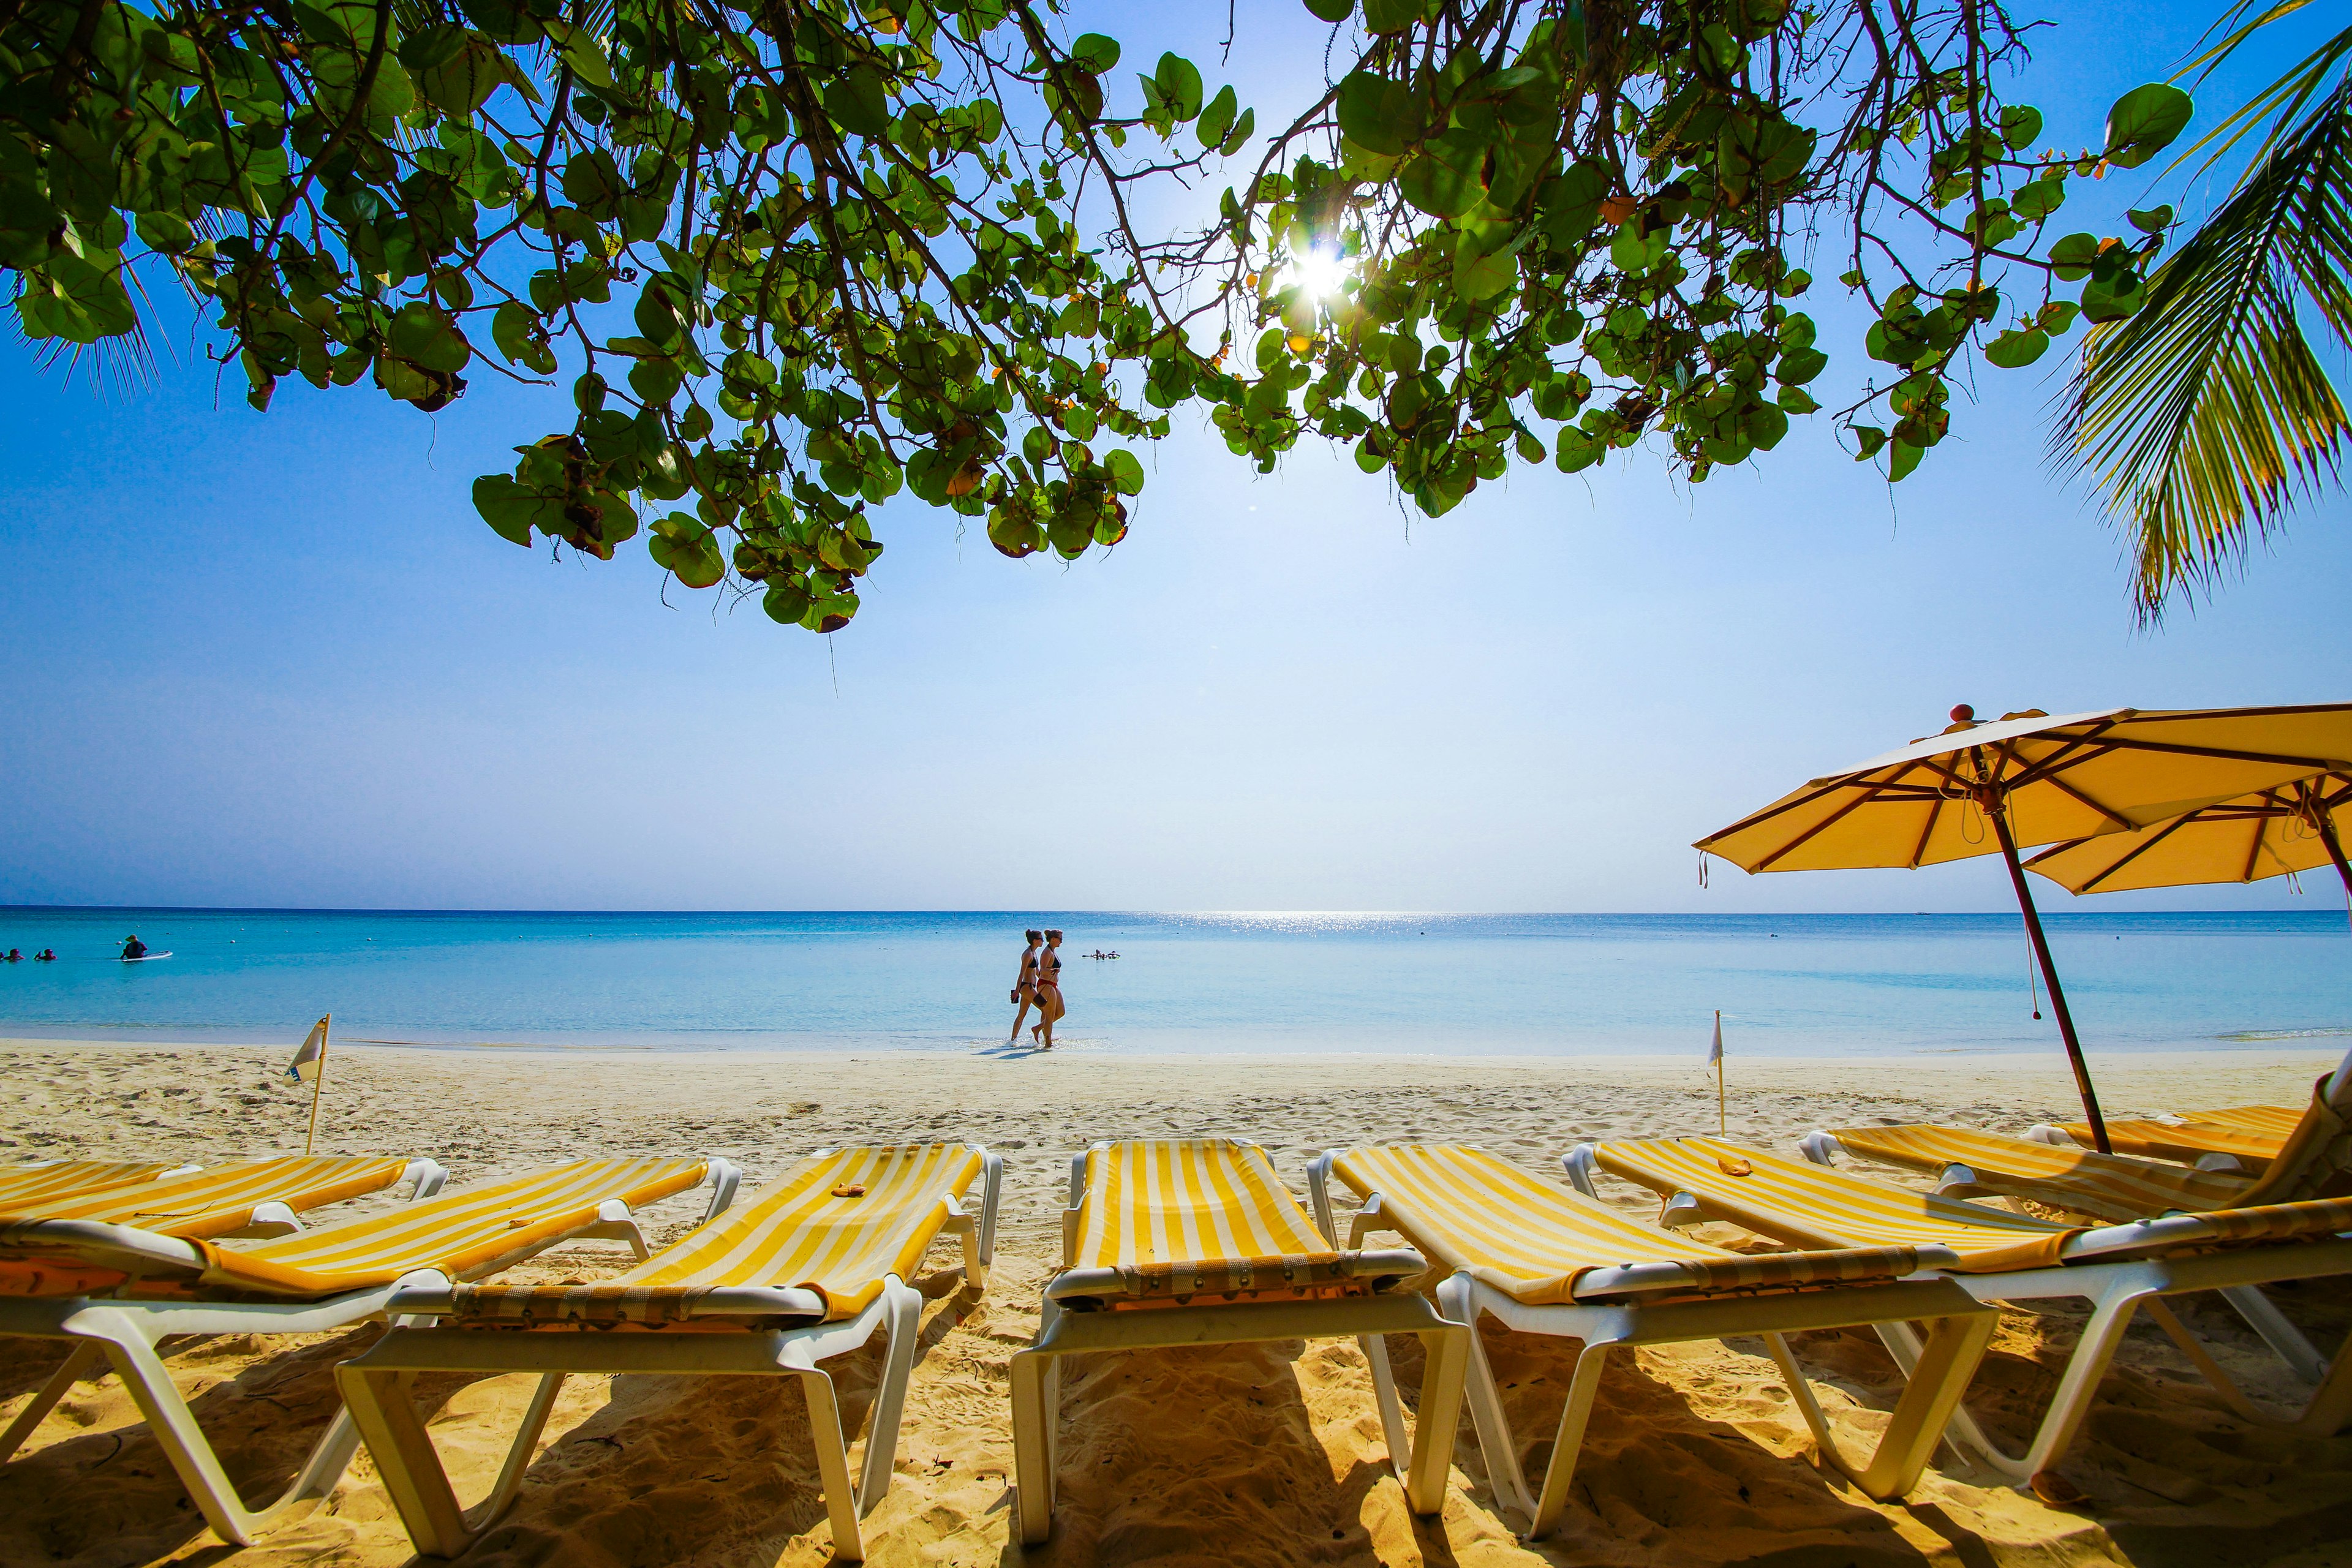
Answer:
[{"left": 0, "top": 1039, "right": 2352, "bottom": 1568}]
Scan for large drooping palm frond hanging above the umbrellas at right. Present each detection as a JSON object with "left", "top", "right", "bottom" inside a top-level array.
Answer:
[{"left": 2051, "top": 82, "right": 2352, "bottom": 620}]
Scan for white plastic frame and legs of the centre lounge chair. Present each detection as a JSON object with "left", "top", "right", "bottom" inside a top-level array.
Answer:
[{"left": 1011, "top": 1140, "right": 1472, "bottom": 1547}]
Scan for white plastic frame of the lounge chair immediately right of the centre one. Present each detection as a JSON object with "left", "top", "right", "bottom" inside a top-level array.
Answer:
[{"left": 1308, "top": 1150, "right": 1999, "bottom": 1540}]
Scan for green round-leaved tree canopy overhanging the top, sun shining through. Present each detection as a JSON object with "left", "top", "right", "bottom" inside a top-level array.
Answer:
[{"left": 0, "top": 0, "right": 2190, "bottom": 632}]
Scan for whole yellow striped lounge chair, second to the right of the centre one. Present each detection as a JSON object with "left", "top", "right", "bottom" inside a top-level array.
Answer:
[{"left": 1566, "top": 1138, "right": 2352, "bottom": 1483}]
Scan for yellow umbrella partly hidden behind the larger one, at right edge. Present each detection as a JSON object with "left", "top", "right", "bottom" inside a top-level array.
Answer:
[{"left": 2025, "top": 771, "right": 2352, "bottom": 893}]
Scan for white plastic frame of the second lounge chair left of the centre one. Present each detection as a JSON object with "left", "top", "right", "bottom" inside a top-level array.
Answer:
[{"left": 0, "top": 1156, "right": 741, "bottom": 1547}]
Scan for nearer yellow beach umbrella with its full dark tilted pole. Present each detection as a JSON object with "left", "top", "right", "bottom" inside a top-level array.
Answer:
[{"left": 1698, "top": 703, "right": 2352, "bottom": 1150}]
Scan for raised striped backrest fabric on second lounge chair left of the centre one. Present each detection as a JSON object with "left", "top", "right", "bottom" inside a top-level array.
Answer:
[{"left": 162, "top": 1159, "right": 708, "bottom": 1295}]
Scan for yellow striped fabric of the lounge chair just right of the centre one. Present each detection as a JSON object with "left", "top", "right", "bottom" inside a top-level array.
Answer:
[{"left": 1331, "top": 1145, "right": 1919, "bottom": 1307}]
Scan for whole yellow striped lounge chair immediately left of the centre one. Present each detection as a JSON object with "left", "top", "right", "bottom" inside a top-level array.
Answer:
[{"left": 336, "top": 1142, "right": 1002, "bottom": 1561}]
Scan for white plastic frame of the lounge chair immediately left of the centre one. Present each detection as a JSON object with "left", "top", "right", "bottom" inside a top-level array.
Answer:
[{"left": 334, "top": 1145, "right": 1005, "bottom": 1563}]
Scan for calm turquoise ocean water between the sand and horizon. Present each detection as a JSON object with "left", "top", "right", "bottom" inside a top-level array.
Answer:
[{"left": 0, "top": 907, "right": 2352, "bottom": 1055}]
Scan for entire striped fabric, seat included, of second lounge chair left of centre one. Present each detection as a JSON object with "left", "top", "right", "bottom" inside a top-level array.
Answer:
[{"left": 0, "top": 1159, "right": 708, "bottom": 1298}]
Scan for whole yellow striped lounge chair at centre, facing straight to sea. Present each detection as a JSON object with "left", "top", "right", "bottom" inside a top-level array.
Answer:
[{"left": 1011, "top": 1138, "right": 1470, "bottom": 1545}]
